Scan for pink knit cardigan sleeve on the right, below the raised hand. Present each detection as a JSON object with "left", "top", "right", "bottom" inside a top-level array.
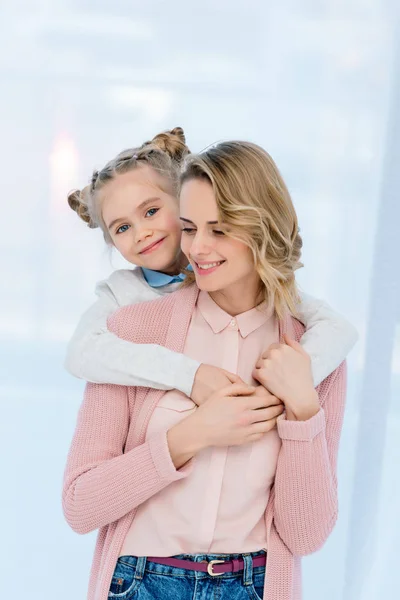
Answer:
[{"left": 274, "top": 362, "right": 347, "bottom": 556}]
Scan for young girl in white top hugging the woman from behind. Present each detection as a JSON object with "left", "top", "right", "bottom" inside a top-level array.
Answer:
[{"left": 66, "top": 127, "right": 357, "bottom": 405}]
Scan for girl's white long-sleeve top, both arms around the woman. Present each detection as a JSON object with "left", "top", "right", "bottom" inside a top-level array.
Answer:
[{"left": 65, "top": 268, "right": 358, "bottom": 397}]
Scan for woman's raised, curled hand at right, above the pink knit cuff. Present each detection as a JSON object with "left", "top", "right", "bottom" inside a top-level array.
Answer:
[{"left": 252, "top": 335, "right": 320, "bottom": 421}]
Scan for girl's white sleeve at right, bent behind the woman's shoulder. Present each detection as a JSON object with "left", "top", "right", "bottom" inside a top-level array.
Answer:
[{"left": 298, "top": 292, "right": 358, "bottom": 386}]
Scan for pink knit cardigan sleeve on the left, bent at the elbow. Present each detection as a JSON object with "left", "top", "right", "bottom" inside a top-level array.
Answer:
[{"left": 62, "top": 383, "right": 192, "bottom": 534}]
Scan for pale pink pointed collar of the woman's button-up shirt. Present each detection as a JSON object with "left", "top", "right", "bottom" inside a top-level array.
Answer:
[{"left": 197, "top": 291, "right": 273, "bottom": 338}]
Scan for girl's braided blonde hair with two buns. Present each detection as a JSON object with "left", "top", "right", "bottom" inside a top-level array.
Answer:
[{"left": 68, "top": 127, "right": 190, "bottom": 244}]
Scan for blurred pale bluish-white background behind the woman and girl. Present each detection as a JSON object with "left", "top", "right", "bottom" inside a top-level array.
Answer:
[{"left": 0, "top": 0, "right": 400, "bottom": 600}]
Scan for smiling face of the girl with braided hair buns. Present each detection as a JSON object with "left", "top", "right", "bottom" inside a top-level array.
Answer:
[{"left": 101, "top": 165, "right": 187, "bottom": 274}]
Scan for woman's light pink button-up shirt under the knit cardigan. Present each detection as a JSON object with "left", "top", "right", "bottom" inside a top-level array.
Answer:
[{"left": 120, "top": 292, "right": 281, "bottom": 556}]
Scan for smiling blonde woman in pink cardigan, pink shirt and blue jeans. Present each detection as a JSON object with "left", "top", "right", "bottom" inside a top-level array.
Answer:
[{"left": 63, "top": 134, "right": 354, "bottom": 600}]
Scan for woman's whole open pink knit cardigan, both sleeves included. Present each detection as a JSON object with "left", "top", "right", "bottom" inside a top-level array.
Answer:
[{"left": 63, "top": 285, "right": 346, "bottom": 600}]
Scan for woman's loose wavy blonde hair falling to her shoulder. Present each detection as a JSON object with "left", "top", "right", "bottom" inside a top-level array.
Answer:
[{"left": 180, "top": 141, "right": 303, "bottom": 318}]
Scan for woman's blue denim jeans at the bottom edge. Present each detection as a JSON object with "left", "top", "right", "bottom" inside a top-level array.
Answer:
[{"left": 108, "top": 550, "right": 265, "bottom": 600}]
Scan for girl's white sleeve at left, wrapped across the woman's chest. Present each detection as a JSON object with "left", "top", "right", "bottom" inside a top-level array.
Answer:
[{"left": 65, "top": 281, "right": 200, "bottom": 397}]
